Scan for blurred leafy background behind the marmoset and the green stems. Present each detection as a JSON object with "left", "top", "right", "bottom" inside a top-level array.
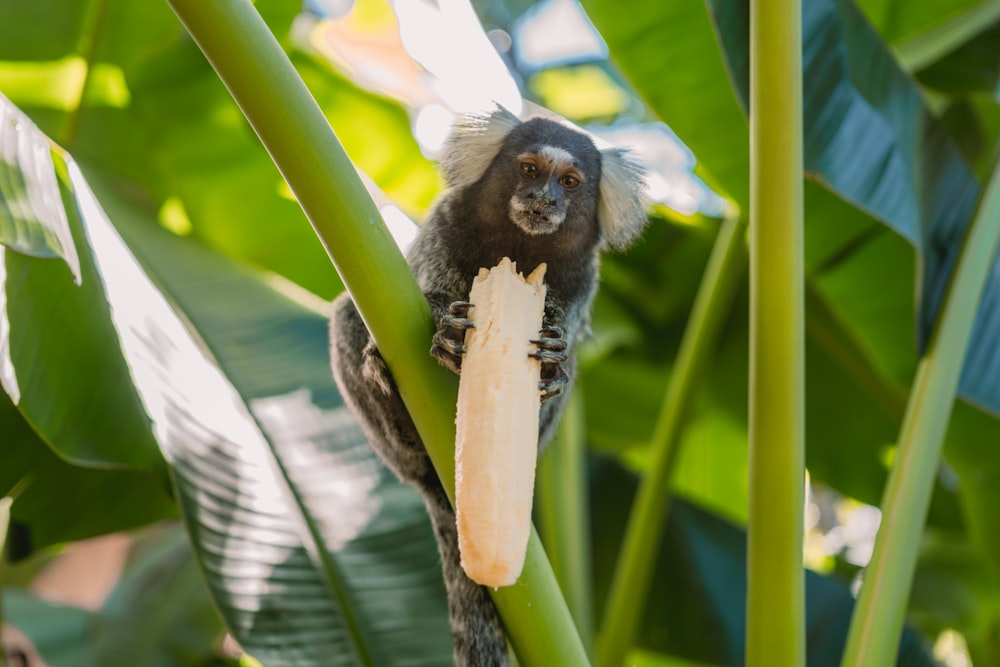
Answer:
[{"left": 0, "top": 0, "right": 1000, "bottom": 667}]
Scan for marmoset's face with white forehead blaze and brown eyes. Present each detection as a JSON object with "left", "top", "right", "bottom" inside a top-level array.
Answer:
[{"left": 508, "top": 145, "right": 589, "bottom": 236}]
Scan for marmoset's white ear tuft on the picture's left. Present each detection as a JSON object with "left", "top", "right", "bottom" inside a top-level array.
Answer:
[{"left": 441, "top": 104, "right": 521, "bottom": 188}]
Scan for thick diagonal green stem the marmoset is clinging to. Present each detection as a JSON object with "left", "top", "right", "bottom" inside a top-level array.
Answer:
[{"left": 160, "top": 0, "right": 588, "bottom": 667}]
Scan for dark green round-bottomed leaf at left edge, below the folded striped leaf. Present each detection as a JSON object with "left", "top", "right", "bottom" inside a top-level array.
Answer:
[{"left": 0, "top": 145, "right": 162, "bottom": 467}]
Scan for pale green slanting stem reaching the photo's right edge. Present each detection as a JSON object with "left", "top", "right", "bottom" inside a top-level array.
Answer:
[{"left": 841, "top": 159, "right": 1000, "bottom": 667}]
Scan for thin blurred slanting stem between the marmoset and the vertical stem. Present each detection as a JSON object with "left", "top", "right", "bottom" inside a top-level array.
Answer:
[{"left": 597, "top": 216, "right": 746, "bottom": 667}]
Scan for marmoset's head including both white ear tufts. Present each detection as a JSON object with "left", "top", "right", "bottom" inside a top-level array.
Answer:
[{"left": 441, "top": 107, "right": 646, "bottom": 253}]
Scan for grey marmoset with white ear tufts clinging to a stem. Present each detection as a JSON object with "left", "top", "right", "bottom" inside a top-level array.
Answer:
[{"left": 331, "top": 108, "right": 646, "bottom": 667}]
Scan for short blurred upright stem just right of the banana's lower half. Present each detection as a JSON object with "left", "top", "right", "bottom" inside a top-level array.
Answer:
[{"left": 536, "top": 392, "right": 594, "bottom": 653}]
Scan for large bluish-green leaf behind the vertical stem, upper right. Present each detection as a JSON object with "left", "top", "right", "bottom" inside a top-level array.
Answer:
[{"left": 712, "top": 0, "right": 1000, "bottom": 415}]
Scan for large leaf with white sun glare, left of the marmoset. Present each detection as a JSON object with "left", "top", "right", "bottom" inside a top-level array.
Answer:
[{"left": 75, "top": 166, "right": 451, "bottom": 665}]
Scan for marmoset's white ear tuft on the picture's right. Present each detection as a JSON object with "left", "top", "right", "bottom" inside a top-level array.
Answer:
[{"left": 597, "top": 148, "right": 649, "bottom": 250}]
